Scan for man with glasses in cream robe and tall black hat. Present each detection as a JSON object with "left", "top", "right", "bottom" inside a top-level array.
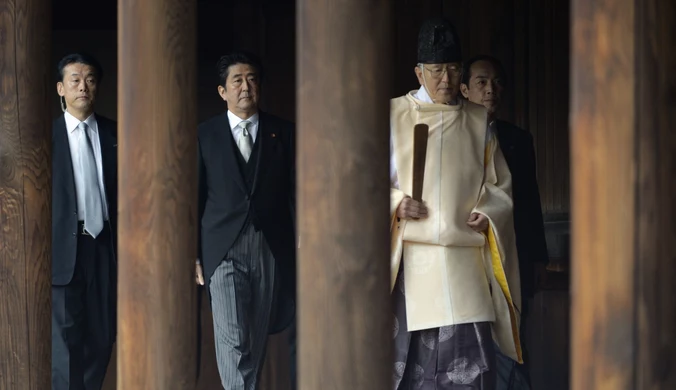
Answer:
[{"left": 390, "top": 19, "right": 521, "bottom": 390}]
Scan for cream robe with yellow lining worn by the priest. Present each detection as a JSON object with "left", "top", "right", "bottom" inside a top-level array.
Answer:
[{"left": 390, "top": 88, "right": 523, "bottom": 362}]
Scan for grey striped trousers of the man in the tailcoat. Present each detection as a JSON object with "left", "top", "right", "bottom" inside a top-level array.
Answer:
[{"left": 209, "top": 223, "right": 279, "bottom": 390}]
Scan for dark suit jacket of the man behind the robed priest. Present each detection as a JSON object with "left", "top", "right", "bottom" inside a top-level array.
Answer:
[{"left": 497, "top": 120, "right": 548, "bottom": 298}]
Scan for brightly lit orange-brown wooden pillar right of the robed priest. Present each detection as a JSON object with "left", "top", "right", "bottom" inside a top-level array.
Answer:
[{"left": 571, "top": 0, "right": 640, "bottom": 390}]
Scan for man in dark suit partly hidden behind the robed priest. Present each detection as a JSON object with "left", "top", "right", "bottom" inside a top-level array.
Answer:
[{"left": 460, "top": 56, "right": 548, "bottom": 390}]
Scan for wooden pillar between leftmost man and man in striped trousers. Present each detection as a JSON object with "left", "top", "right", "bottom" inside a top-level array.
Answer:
[{"left": 117, "top": 0, "right": 197, "bottom": 390}]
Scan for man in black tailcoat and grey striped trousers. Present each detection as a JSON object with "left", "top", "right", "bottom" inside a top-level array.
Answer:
[{"left": 197, "top": 52, "right": 296, "bottom": 390}]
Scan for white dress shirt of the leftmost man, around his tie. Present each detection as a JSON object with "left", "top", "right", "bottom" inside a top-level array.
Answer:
[{"left": 64, "top": 111, "right": 108, "bottom": 221}]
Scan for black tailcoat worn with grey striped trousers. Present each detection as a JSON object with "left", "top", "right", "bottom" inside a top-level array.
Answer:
[{"left": 198, "top": 112, "right": 296, "bottom": 326}]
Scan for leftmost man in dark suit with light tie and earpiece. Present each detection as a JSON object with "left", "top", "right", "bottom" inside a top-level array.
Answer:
[{"left": 52, "top": 54, "right": 117, "bottom": 390}]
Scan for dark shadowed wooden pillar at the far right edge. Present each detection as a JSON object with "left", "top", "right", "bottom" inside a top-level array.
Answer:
[{"left": 634, "top": 0, "right": 676, "bottom": 390}]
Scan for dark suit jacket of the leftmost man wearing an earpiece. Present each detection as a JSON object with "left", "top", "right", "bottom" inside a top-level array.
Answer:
[{"left": 52, "top": 115, "right": 117, "bottom": 286}]
